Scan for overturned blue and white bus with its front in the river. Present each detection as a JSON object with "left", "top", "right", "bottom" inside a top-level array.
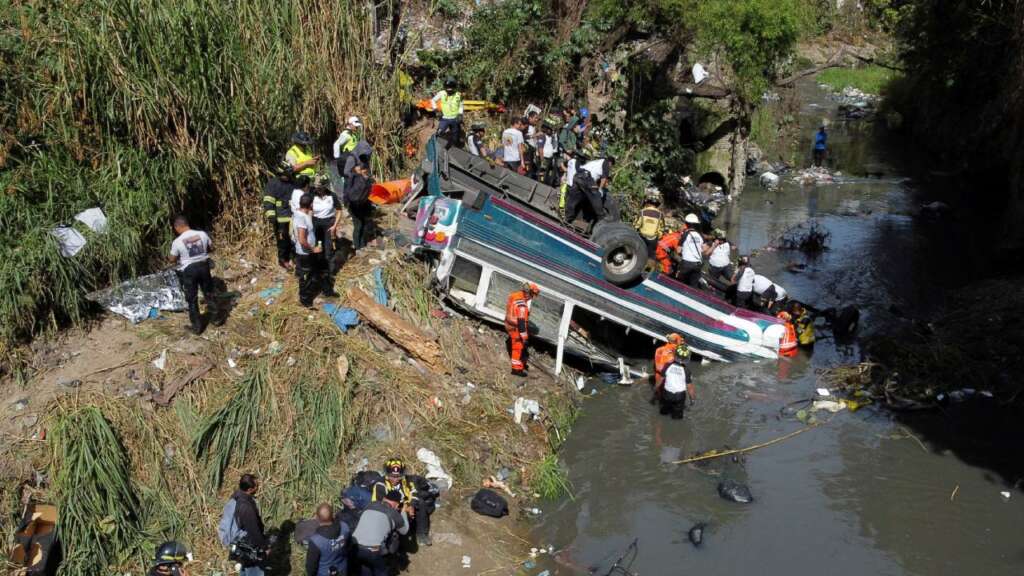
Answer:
[{"left": 413, "top": 142, "right": 784, "bottom": 374}]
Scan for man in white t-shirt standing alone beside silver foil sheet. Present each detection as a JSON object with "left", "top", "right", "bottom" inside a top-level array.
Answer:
[{"left": 170, "top": 215, "right": 219, "bottom": 334}]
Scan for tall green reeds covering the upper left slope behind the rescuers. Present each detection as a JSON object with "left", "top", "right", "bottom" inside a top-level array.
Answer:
[{"left": 0, "top": 0, "right": 401, "bottom": 341}]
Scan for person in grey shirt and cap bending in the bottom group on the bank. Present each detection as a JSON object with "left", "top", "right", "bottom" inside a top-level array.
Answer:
[{"left": 352, "top": 490, "right": 413, "bottom": 576}]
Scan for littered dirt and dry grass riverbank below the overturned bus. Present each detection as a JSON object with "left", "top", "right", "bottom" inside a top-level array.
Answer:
[{"left": 0, "top": 203, "right": 578, "bottom": 576}]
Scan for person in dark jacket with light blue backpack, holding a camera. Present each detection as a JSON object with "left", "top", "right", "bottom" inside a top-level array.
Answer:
[{"left": 217, "top": 474, "right": 270, "bottom": 576}]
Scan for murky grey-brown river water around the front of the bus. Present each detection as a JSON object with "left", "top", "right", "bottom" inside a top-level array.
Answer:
[{"left": 525, "top": 84, "right": 1024, "bottom": 575}]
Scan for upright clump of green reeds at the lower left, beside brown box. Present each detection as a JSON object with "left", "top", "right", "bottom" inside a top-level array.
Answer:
[{"left": 50, "top": 406, "right": 140, "bottom": 576}]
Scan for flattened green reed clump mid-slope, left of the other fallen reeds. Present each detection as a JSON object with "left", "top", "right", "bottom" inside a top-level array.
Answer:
[{"left": 193, "top": 363, "right": 273, "bottom": 489}]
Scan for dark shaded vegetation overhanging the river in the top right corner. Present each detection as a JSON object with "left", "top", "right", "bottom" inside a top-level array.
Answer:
[{"left": 879, "top": 0, "right": 1024, "bottom": 241}]
